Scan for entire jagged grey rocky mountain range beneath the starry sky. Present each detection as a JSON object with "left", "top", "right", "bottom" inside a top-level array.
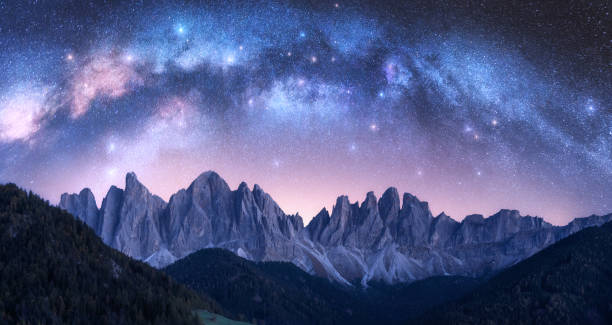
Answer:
[{"left": 60, "top": 171, "right": 612, "bottom": 284}]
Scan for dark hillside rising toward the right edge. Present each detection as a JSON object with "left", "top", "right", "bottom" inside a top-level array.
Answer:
[{"left": 425, "top": 219, "right": 612, "bottom": 324}]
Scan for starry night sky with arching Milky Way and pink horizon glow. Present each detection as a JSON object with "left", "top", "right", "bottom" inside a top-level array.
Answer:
[{"left": 0, "top": 0, "right": 612, "bottom": 224}]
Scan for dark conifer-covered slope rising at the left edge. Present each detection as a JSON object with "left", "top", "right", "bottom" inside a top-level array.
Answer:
[{"left": 0, "top": 184, "right": 224, "bottom": 324}]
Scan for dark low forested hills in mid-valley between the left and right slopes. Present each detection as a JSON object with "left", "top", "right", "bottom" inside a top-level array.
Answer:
[{"left": 164, "top": 248, "right": 478, "bottom": 324}]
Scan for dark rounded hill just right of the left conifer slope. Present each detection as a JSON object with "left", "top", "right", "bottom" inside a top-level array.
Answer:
[{"left": 164, "top": 248, "right": 370, "bottom": 324}]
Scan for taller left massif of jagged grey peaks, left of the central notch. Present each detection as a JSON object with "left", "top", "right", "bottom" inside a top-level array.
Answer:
[{"left": 60, "top": 172, "right": 304, "bottom": 267}]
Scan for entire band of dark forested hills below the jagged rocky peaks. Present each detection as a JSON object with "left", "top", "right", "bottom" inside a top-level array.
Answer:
[{"left": 0, "top": 184, "right": 612, "bottom": 325}]
